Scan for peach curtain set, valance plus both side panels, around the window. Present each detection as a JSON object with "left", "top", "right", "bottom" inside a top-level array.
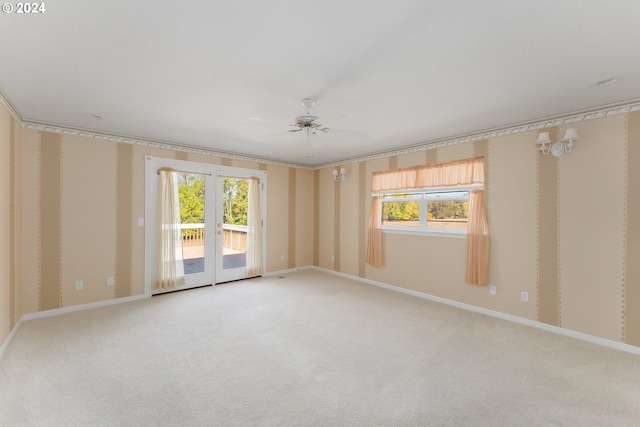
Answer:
[{"left": 366, "top": 157, "right": 489, "bottom": 285}]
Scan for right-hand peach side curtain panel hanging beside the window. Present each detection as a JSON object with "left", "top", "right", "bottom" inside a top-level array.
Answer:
[{"left": 466, "top": 190, "right": 489, "bottom": 285}]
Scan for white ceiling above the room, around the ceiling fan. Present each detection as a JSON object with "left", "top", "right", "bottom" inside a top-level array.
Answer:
[{"left": 0, "top": 0, "right": 640, "bottom": 166}]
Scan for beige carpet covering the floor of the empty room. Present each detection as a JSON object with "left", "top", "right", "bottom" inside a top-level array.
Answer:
[{"left": 0, "top": 270, "right": 640, "bottom": 426}]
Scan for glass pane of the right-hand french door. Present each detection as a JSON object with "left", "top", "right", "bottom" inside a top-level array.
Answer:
[{"left": 222, "top": 177, "right": 249, "bottom": 270}]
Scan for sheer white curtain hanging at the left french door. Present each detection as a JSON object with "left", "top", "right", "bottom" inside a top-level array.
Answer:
[{"left": 154, "top": 168, "right": 184, "bottom": 289}]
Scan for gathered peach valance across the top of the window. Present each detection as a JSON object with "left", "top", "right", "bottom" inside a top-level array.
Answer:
[{"left": 371, "top": 157, "right": 484, "bottom": 193}]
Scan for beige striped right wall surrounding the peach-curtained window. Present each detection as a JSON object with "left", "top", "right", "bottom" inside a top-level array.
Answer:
[{"left": 316, "top": 113, "right": 640, "bottom": 345}]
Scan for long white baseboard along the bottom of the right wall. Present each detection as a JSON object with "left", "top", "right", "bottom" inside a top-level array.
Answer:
[{"left": 310, "top": 266, "right": 640, "bottom": 356}]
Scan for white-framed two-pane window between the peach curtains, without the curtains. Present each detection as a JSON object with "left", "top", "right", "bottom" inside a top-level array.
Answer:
[{"left": 380, "top": 189, "right": 469, "bottom": 235}]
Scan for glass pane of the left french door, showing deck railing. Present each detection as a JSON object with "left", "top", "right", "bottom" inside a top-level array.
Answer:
[{"left": 178, "top": 172, "right": 205, "bottom": 274}]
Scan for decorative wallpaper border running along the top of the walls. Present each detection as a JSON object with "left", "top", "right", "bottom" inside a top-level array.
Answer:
[{"left": 0, "top": 90, "right": 640, "bottom": 170}]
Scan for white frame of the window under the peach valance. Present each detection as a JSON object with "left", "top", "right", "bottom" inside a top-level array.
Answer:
[{"left": 373, "top": 184, "right": 484, "bottom": 239}]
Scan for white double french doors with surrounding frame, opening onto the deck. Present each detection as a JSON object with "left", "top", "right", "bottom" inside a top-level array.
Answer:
[{"left": 145, "top": 156, "right": 266, "bottom": 295}]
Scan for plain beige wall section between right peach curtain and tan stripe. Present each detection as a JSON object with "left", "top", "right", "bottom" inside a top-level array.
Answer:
[{"left": 488, "top": 132, "right": 538, "bottom": 319}]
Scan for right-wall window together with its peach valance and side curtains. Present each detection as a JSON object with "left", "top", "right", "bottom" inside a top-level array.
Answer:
[{"left": 365, "top": 157, "right": 489, "bottom": 285}]
